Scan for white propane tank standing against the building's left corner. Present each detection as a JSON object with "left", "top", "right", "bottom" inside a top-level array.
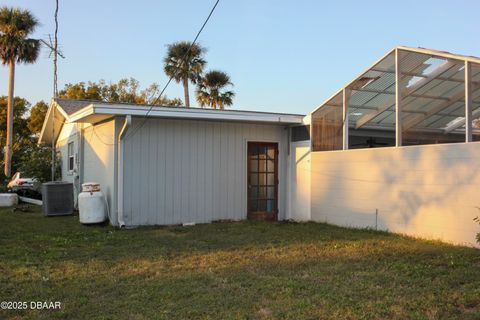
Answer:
[{"left": 78, "top": 182, "right": 106, "bottom": 224}]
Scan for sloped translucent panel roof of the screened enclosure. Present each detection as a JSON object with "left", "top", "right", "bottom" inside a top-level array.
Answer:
[{"left": 311, "top": 46, "right": 480, "bottom": 133}]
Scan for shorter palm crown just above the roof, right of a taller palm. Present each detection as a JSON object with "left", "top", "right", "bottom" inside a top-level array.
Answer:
[{"left": 197, "top": 70, "right": 235, "bottom": 110}]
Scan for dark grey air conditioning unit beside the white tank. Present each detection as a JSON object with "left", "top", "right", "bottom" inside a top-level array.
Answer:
[{"left": 42, "top": 181, "right": 73, "bottom": 216}]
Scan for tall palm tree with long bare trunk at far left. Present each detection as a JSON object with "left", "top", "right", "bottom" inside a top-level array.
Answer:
[{"left": 0, "top": 7, "right": 40, "bottom": 177}]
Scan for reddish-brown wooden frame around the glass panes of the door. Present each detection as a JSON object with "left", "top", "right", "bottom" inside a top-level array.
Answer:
[{"left": 245, "top": 139, "right": 280, "bottom": 221}]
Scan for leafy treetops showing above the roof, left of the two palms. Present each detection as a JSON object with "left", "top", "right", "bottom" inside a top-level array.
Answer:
[{"left": 58, "top": 78, "right": 182, "bottom": 106}]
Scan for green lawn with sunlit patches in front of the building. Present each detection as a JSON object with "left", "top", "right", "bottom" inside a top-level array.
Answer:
[{"left": 0, "top": 207, "right": 480, "bottom": 319}]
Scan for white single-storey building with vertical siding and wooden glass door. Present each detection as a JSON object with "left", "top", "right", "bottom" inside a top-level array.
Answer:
[{"left": 40, "top": 99, "right": 309, "bottom": 226}]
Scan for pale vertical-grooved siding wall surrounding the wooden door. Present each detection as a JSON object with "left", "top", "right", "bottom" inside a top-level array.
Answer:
[{"left": 123, "top": 118, "right": 288, "bottom": 226}]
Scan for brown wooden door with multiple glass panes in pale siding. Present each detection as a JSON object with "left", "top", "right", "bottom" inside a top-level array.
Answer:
[{"left": 247, "top": 142, "right": 278, "bottom": 221}]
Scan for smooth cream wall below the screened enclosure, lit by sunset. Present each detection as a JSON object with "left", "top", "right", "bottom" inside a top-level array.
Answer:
[{"left": 311, "top": 142, "right": 480, "bottom": 245}]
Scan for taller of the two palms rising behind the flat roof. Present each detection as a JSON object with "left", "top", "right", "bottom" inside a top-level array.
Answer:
[{"left": 164, "top": 41, "right": 207, "bottom": 108}]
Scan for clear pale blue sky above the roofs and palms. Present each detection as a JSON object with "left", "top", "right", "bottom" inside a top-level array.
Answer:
[{"left": 0, "top": 0, "right": 480, "bottom": 113}]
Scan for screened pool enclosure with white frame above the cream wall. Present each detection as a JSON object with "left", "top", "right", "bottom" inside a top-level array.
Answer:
[{"left": 311, "top": 46, "right": 480, "bottom": 151}]
